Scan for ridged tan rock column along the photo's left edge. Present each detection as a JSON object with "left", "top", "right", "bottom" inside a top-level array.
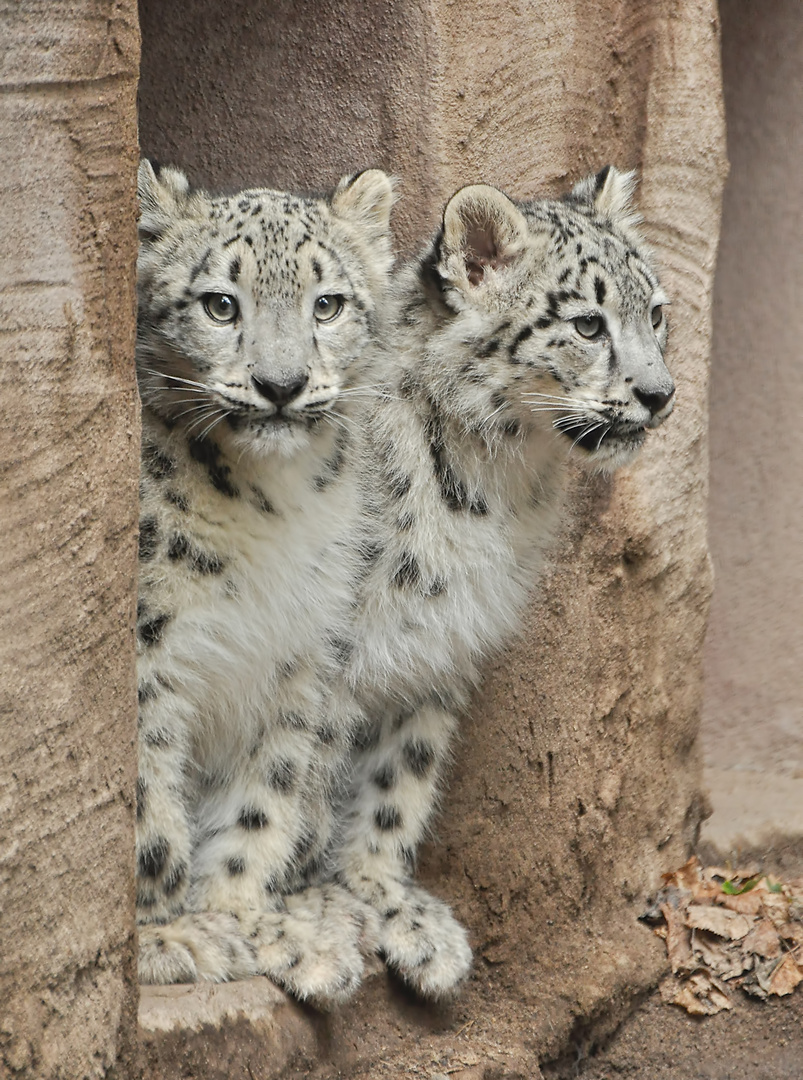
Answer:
[{"left": 0, "top": 0, "right": 139, "bottom": 1080}]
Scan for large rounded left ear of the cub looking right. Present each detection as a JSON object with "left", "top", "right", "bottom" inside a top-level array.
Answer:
[{"left": 438, "top": 184, "right": 529, "bottom": 291}]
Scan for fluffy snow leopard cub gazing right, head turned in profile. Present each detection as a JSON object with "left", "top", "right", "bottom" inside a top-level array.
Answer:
[{"left": 330, "top": 167, "right": 675, "bottom": 996}]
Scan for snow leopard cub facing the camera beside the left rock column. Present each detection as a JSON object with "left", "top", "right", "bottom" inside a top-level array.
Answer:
[{"left": 137, "top": 161, "right": 393, "bottom": 1000}]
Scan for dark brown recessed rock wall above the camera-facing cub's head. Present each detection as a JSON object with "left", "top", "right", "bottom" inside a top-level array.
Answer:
[{"left": 139, "top": 0, "right": 441, "bottom": 246}]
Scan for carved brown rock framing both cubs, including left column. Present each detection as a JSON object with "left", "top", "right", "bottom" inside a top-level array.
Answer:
[{"left": 0, "top": 0, "right": 724, "bottom": 1080}]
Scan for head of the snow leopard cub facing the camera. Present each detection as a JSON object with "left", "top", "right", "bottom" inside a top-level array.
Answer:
[{"left": 137, "top": 161, "right": 393, "bottom": 454}]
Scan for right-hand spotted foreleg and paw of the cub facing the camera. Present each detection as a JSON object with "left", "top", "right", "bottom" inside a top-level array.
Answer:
[{"left": 170, "top": 671, "right": 377, "bottom": 1003}]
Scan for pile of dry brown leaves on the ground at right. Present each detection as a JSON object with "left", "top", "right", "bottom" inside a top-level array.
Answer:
[{"left": 643, "top": 856, "right": 803, "bottom": 1015}]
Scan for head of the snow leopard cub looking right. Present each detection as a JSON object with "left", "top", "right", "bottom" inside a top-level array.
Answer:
[{"left": 436, "top": 168, "right": 675, "bottom": 470}]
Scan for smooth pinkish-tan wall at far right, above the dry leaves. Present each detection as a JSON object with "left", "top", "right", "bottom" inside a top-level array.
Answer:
[{"left": 703, "top": 0, "right": 803, "bottom": 854}]
